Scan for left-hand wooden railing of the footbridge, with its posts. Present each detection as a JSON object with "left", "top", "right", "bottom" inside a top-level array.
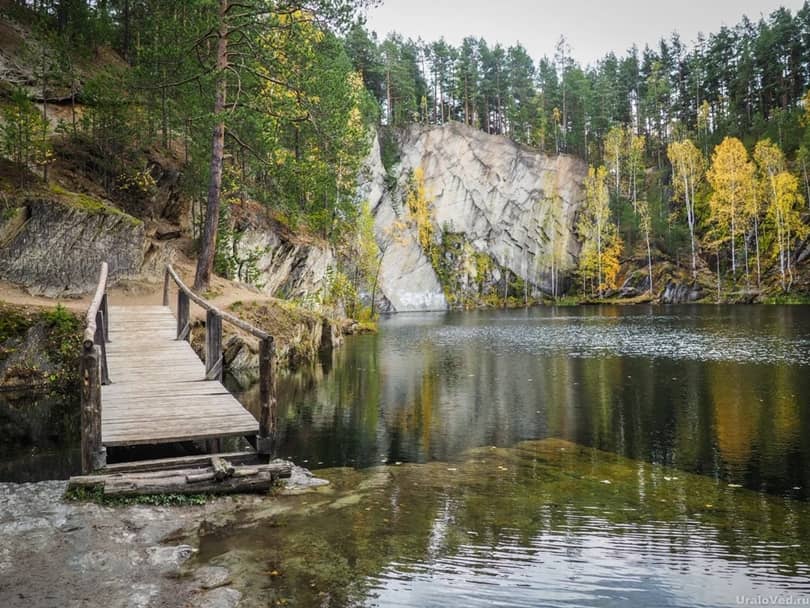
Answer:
[{"left": 79, "top": 262, "right": 110, "bottom": 473}]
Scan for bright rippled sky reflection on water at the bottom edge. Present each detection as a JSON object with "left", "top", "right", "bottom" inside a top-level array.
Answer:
[{"left": 371, "top": 516, "right": 810, "bottom": 608}]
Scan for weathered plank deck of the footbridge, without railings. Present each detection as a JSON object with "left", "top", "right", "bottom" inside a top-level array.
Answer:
[{"left": 101, "top": 306, "right": 259, "bottom": 447}]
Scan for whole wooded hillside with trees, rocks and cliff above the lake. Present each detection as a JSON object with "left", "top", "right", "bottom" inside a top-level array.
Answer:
[{"left": 0, "top": 3, "right": 810, "bottom": 319}]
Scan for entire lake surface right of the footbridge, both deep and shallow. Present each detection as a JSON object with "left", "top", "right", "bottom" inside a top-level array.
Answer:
[{"left": 213, "top": 306, "right": 810, "bottom": 607}]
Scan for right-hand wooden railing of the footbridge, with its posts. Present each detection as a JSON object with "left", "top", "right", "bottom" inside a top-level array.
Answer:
[{"left": 163, "top": 265, "right": 277, "bottom": 455}]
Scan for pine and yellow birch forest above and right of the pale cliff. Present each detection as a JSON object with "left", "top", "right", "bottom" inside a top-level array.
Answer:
[{"left": 346, "top": 3, "right": 810, "bottom": 294}]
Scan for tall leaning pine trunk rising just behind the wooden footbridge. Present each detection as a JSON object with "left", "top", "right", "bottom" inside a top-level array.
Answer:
[{"left": 194, "top": 0, "right": 229, "bottom": 291}]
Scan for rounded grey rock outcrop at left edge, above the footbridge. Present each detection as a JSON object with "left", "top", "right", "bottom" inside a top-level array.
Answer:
[{"left": 0, "top": 194, "right": 150, "bottom": 297}]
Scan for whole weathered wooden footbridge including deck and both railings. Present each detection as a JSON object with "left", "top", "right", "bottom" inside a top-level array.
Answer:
[{"left": 80, "top": 263, "right": 276, "bottom": 476}]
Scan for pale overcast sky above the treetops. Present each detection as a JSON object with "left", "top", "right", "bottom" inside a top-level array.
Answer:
[{"left": 368, "top": 0, "right": 804, "bottom": 64}]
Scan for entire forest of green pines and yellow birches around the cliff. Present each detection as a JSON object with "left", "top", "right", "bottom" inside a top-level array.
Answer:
[{"left": 2, "top": 0, "right": 810, "bottom": 297}]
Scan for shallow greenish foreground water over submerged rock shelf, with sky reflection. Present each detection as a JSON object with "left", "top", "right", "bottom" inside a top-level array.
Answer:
[{"left": 193, "top": 439, "right": 810, "bottom": 607}]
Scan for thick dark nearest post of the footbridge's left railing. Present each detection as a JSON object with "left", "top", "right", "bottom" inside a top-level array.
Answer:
[{"left": 81, "top": 342, "right": 107, "bottom": 474}]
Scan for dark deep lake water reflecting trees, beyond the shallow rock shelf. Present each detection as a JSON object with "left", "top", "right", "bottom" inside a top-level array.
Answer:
[{"left": 234, "top": 306, "right": 810, "bottom": 496}]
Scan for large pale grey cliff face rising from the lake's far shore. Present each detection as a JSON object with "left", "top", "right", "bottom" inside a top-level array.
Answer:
[{"left": 361, "top": 123, "right": 587, "bottom": 311}]
